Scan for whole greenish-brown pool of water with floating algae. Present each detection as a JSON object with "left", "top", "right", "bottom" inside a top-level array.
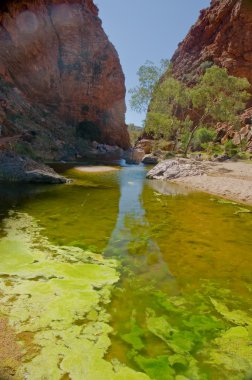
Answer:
[{"left": 0, "top": 166, "right": 252, "bottom": 380}]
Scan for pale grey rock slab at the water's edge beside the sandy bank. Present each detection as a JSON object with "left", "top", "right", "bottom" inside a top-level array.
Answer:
[{"left": 147, "top": 158, "right": 209, "bottom": 179}]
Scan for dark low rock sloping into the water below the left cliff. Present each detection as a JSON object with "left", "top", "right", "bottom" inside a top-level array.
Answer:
[{"left": 0, "top": 151, "right": 69, "bottom": 183}]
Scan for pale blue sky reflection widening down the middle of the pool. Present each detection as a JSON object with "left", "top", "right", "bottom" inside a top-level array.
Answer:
[{"left": 105, "top": 165, "right": 173, "bottom": 281}]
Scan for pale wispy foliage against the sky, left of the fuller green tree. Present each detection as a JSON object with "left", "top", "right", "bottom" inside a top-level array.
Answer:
[{"left": 129, "top": 59, "right": 170, "bottom": 112}]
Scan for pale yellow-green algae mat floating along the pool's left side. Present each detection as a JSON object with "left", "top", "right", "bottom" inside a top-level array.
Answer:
[{"left": 0, "top": 213, "right": 149, "bottom": 380}]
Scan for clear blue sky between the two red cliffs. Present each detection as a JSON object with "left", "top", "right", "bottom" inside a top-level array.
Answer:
[{"left": 95, "top": 0, "right": 210, "bottom": 125}]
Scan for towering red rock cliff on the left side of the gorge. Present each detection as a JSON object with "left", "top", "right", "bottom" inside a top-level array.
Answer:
[{"left": 0, "top": 0, "right": 129, "bottom": 159}]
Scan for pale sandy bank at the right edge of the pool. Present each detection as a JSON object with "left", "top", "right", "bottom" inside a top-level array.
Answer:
[{"left": 173, "top": 162, "right": 252, "bottom": 205}]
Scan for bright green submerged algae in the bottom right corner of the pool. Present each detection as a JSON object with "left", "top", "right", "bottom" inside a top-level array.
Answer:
[{"left": 115, "top": 285, "right": 252, "bottom": 380}]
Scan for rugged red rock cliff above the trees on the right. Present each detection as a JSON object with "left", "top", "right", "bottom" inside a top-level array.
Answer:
[{"left": 172, "top": 0, "right": 252, "bottom": 93}]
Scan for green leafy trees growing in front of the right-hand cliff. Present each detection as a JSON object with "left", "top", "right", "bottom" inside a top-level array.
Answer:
[{"left": 131, "top": 61, "right": 250, "bottom": 156}]
